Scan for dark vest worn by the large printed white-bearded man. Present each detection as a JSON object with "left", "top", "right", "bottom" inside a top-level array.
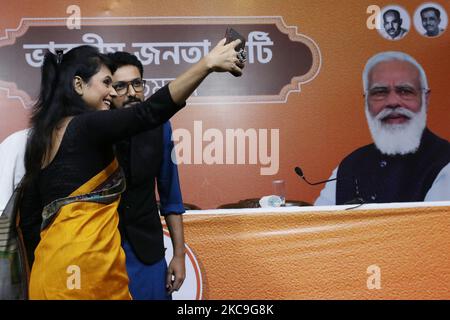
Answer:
[{"left": 336, "top": 129, "right": 450, "bottom": 204}]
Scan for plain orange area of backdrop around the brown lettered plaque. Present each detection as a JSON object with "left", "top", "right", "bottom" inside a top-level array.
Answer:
[{"left": 0, "top": 0, "right": 450, "bottom": 208}]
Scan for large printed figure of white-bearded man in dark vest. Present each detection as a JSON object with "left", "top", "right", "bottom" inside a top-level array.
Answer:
[{"left": 315, "top": 51, "right": 450, "bottom": 205}]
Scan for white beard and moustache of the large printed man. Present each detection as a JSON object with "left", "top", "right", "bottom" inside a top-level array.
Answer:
[{"left": 365, "top": 100, "right": 427, "bottom": 155}]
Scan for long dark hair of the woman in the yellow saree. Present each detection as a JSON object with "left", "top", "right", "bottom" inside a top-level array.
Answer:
[{"left": 25, "top": 46, "right": 115, "bottom": 183}]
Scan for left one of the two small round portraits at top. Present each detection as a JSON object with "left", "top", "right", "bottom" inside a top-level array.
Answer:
[{"left": 378, "top": 6, "right": 411, "bottom": 41}]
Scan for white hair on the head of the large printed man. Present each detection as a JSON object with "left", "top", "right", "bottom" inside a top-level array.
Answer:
[{"left": 362, "top": 51, "right": 429, "bottom": 92}]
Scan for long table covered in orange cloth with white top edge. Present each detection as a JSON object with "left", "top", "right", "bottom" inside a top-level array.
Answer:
[{"left": 166, "top": 202, "right": 450, "bottom": 299}]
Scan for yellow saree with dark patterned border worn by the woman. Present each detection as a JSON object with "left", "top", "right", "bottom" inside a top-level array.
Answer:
[{"left": 29, "top": 160, "right": 131, "bottom": 299}]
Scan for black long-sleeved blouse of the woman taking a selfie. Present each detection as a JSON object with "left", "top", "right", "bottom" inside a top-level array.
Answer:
[{"left": 20, "top": 86, "right": 185, "bottom": 259}]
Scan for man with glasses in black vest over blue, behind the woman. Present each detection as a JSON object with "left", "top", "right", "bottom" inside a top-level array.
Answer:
[{"left": 109, "top": 52, "right": 185, "bottom": 300}]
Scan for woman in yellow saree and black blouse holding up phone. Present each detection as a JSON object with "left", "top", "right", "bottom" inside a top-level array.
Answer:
[{"left": 21, "top": 40, "right": 243, "bottom": 299}]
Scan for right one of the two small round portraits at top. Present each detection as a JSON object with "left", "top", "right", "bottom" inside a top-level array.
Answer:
[{"left": 414, "top": 2, "right": 448, "bottom": 38}]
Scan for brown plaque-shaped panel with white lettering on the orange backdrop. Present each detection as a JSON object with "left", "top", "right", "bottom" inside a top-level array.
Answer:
[{"left": 0, "top": 17, "right": 321, "bottom": 106}]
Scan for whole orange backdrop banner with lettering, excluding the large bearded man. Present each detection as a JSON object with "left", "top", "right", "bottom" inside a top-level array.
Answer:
[{"left": 0, "top": 0, "right": 450, "bottom": 209}]
